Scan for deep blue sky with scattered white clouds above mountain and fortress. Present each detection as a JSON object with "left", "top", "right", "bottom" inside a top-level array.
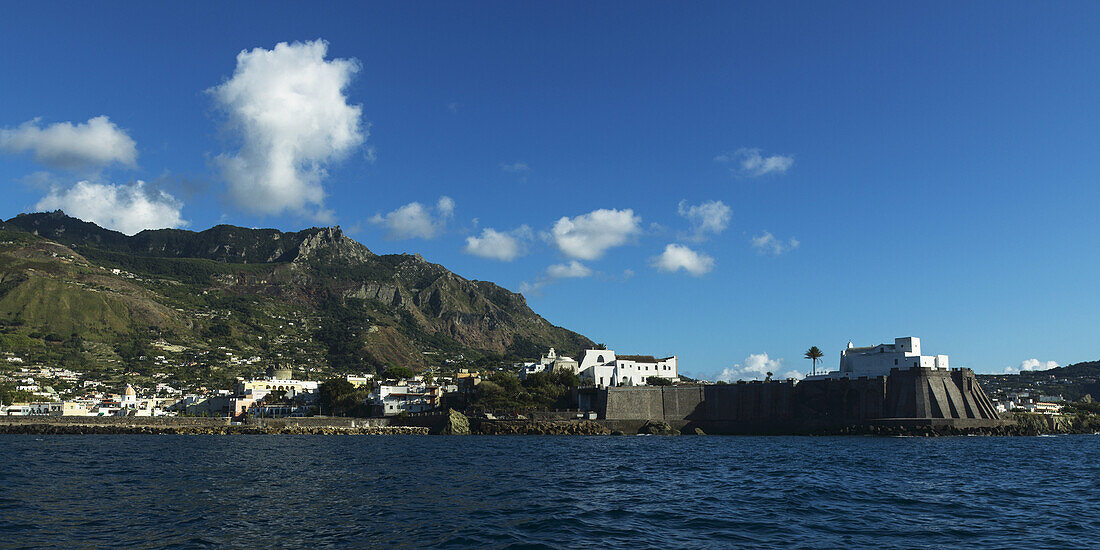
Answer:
[{"left": 0, "top": 1, "right": 1100, "bottom": 380}]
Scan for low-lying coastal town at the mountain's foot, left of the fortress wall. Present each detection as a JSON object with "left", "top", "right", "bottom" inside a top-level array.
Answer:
[{"left": 0, "top": 343, "right": 681, "bottom": 419}]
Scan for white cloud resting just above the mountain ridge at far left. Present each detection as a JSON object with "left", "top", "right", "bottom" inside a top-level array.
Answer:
[{"left": 34, "top": 180, "right": 187, "bottom": 235}]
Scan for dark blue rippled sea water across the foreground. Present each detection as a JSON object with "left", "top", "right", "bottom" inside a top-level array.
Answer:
[{"left": 0, "top": 436, "right": 1100, "bottom": 549}]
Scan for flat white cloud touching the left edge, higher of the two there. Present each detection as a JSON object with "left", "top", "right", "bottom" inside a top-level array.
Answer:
[{"left": 0, "top": 117, "right": 138, "bottom": 169}]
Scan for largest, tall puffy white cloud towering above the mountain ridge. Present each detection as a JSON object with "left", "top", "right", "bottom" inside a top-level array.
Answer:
[{"left": 209, "top": 40, "right": 372, "bottom": 215}]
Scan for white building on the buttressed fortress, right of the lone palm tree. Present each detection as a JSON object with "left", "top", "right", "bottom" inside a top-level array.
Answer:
[{"left": 806, "top": 337, "right": 949, "bottom": 380}]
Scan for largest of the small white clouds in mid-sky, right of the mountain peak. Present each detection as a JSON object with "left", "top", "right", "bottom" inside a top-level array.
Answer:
[{"left": 550, "top": 208, "right": 641, "bottom": 260}]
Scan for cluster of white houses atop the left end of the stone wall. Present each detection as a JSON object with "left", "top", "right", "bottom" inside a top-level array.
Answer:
[{"left": 519, "top": 348, "right": 680, "bottom": 387}]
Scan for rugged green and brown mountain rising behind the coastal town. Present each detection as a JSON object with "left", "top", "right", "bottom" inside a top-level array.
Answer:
[{"left": 0, "top": 211, "right": 593, "bottom": 387}]
